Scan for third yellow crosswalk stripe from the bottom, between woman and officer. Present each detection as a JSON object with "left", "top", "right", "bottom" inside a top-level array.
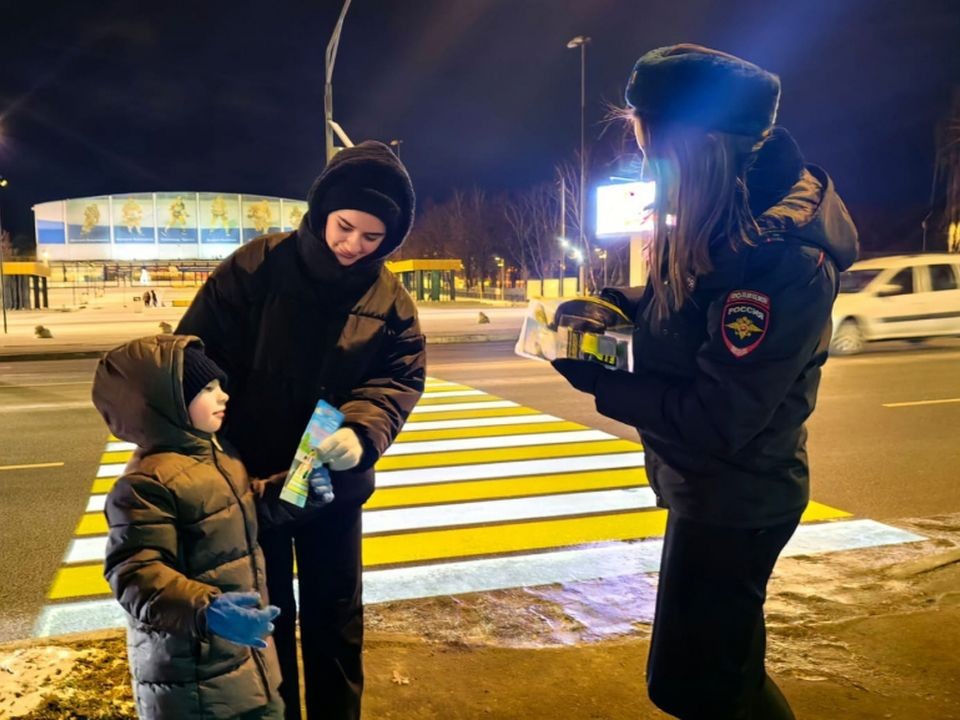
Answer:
[{"left": 376, "top": 439, "right": 641, "bottom": 470}]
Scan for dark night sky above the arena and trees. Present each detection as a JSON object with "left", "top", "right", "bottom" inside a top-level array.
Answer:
[{"left": 0, "top": 0, "right": 960, "bottom": 249}]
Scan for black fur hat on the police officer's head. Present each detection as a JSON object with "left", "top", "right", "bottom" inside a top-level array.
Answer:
[{"left": 625, "top": 44, "right": 780, "bottom": 137}]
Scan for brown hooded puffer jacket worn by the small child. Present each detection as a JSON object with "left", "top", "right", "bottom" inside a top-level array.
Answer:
[{"left": 93, "top": 335, "right": 280, "bottom": 720}]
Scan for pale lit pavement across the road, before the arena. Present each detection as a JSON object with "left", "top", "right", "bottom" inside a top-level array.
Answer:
[{"left": 0, "top": 302, "right": 524, "bottom": 361}]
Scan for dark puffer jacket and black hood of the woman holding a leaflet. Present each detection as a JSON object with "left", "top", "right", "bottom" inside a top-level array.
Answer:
[{"left": 178, "top": 142, "right": 426, "bottom": 500}]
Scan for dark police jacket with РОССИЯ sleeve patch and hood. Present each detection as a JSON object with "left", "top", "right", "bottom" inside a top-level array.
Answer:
[{"left": 596, "top": 132, "right": 858, "bottom": 527}]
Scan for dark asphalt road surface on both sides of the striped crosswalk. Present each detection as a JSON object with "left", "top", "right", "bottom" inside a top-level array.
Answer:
[{"left": 0, "top": 340, "right": 960, "bottom": 641}]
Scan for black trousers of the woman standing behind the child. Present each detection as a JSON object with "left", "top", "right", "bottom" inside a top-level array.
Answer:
[{"left": 260, "top": 501, "right": 363, "bottom": 720}]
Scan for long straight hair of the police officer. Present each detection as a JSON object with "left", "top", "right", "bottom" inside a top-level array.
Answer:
[{"left": 631, "top": 116, "right": 759, "bottom": 318}]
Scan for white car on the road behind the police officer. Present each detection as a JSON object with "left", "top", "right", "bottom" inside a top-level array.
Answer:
[{"left": 830, "top": 253, "right": 960, "bottom": 355}]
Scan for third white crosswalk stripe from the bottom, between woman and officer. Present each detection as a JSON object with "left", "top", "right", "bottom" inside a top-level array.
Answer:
[{"left": 377, "top": 452, "right": 643, "bottom": 487}]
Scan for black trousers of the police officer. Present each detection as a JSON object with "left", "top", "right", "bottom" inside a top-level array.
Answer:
[{"left": 647, "top": 513, "right": 799, "bottom": 720}]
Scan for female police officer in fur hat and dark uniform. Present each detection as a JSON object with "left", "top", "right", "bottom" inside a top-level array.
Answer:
[{"left": 554, "top": 45, "right": 857, "bottom": 720}]
